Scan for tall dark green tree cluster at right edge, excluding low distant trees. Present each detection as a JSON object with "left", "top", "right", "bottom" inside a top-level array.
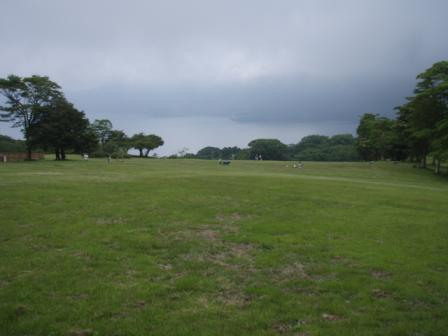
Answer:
[{"left": 356, "top": 61, "right": 448, "bottom": 174}]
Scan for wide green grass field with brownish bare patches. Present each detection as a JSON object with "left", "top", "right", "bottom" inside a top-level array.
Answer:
[{"left": 0, "top": 159, "right": 448, "bottom": 336}]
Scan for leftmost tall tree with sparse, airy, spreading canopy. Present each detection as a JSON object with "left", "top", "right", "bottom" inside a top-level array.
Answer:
[{"left": 0, "top": 75, "right": 63, "bottom": 160}]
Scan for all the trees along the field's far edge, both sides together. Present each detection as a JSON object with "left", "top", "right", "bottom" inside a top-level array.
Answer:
[{"left": 0, "top": 61, "right": 448, "bottom": 168}]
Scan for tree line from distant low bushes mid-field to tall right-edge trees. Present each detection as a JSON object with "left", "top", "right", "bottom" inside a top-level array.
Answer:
[{"left": 194, "top": 61, "right": 448, "bottom": 173}]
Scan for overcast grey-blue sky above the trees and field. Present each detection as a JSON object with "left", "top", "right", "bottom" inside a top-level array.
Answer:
[{"left": 0, "top": 0, "right": 448, "bottom": 155}]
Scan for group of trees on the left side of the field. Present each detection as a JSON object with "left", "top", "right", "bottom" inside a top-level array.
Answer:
[{"left": 0, "top": 75, "right": 163, "bottom": 160}]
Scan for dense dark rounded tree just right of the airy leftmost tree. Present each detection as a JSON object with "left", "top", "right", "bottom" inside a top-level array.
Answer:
[{"left": 30, "top": 97, "right": 98, "bottom": 160}]
